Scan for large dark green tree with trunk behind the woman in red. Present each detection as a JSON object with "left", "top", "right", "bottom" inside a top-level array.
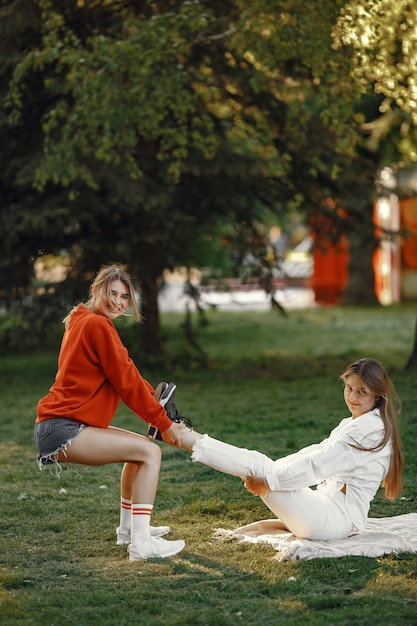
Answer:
[{"left": 0, "top": 0, "right": 400, "bottom": 353}]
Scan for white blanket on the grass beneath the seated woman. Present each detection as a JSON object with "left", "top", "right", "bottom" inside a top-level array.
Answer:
[{"left": 215, "top": 513, "right": 417, "bottom": 561}]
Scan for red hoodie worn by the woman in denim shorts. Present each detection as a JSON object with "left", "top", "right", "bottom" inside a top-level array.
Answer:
[{"left": 36, "top": 306, "right": 172, "bottom": 432}]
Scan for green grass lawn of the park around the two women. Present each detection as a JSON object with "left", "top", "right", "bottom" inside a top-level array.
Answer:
[{"left": 0, "top": 305, "right": 417, "bottom": 626}]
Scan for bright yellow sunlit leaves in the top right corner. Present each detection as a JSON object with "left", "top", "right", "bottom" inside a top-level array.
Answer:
[{"left": 335, "top": 0, "right": 417, "bottom": 165}]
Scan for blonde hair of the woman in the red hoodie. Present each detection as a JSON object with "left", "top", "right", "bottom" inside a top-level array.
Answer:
[{"left": 62, "top": 264, "right": 142, "bottom": 328}]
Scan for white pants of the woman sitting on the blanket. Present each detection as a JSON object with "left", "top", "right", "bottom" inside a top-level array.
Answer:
[{"left": 191, "top": 435, "right": 353, "bottom": 540}]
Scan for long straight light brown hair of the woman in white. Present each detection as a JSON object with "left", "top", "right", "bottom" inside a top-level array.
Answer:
[{"left": 340, "top": 358, "right": 404, "bottom": 500}]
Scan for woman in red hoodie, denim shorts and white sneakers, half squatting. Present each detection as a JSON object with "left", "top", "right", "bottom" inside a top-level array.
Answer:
[{"left": 34, "top": 265, "right": 184, "bottom": 560}]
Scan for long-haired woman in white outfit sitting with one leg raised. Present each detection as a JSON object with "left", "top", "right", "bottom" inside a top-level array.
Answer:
[{"left": 151, "top": 358, "right": 403, "bottom": 540}]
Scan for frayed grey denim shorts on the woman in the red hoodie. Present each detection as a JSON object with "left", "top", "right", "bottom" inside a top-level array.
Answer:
[{"left": 33, "top": 417, "right": 85, "bottom": 469}]
